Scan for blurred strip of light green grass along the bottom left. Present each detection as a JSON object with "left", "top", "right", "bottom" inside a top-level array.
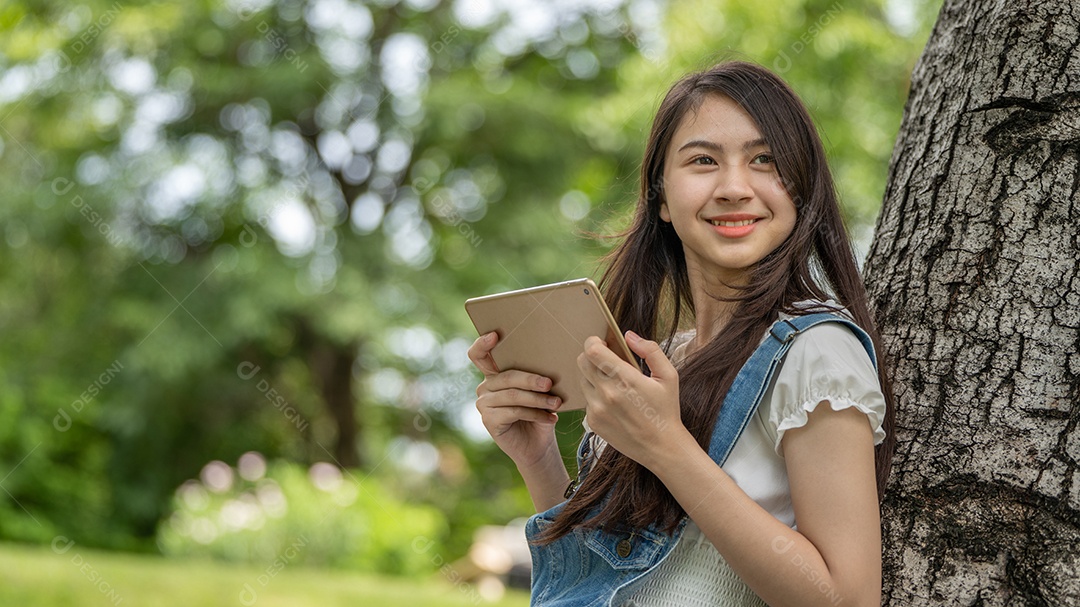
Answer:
[{"left": 0, "top": 543, "right": 528, "bottom": 607}]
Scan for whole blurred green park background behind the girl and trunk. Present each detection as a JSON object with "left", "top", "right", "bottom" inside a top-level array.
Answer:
[{"left": 0, "top": 0, "right": 940, "bottom": 606}]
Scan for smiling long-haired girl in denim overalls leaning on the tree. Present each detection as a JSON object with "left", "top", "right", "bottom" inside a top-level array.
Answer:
[{"left": 469, "top": 63, "right": 893, "bottom": 607}]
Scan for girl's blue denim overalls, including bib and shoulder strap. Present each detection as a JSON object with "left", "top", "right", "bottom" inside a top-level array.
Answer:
[{"left": 525, "top": 312, "right": 877, "bottom": 607}]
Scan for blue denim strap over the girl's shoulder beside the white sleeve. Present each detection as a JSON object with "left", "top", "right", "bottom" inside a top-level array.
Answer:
[{"left": 708, "top": 312, "right": 877, "bottom": 466}]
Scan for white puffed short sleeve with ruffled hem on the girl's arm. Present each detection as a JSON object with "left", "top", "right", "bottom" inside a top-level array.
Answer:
[{"left": 762, "top": 323, "right": 886, "bottom": 457}]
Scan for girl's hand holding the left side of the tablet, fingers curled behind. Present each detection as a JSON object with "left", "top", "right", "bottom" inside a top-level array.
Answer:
[{"left": 469, "top": 332, "right": 563, "bottom": 469}]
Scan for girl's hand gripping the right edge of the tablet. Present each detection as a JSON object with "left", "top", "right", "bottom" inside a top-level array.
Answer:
[{"left": 578, "top": 331, "right": 687, "bottom": 468}]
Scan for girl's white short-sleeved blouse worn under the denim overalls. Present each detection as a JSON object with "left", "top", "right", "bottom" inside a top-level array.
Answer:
[{"left": 583, "top": 314, "right": 886, "bottom": 607}]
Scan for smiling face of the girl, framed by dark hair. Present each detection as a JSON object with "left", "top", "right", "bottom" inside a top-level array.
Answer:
[{"left": 660, "top": 94, "right": 796, "bottom": 284}]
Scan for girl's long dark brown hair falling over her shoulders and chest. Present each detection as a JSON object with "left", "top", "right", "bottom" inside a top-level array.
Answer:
[{"left": 537, "top": 62, "right": 894, "bottom": 543}]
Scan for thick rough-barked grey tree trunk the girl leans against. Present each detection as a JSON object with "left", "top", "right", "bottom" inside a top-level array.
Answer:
[{"left": 866, "top": 0, "right": 1080, "bottom": 606}]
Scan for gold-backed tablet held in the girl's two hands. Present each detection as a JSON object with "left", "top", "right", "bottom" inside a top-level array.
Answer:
[{"left": 465, "top": 279, "right": 640, "bottom": 410}]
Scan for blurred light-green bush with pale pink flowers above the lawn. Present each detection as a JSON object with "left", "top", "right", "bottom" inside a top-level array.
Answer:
[{"left": 158, "top": 453, "right": 446, "bottom": 575}]
